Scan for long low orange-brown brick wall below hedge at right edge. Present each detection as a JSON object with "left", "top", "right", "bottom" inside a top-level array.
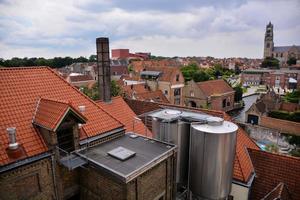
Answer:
[{"left": 260, "top": 116, "right": 300, "bottom": 136}]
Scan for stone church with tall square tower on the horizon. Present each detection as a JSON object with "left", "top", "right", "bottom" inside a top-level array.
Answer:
[{"left": 264, "top": 22, "right": 300, "bottom": 65}]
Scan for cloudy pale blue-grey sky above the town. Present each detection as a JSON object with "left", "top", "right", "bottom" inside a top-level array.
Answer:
[{"left": 0, "top": 0, "right": 300, "bottom": 58}]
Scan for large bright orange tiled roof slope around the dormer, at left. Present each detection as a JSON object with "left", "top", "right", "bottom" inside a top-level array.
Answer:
[{"left": 0, "top": 67, "right": 123, "bottom": 165}]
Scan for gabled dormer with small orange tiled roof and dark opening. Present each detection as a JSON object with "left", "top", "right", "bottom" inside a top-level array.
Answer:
[{"left": 32, "top": 98, "right": 87, "bottom": 152}]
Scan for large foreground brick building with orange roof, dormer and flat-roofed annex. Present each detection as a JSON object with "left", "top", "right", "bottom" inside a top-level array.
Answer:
[{"left": 0, "top": 67, "right": 175, "bottom": 200}]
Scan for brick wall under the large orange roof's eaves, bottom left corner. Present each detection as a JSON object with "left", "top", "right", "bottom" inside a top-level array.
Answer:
[{"left": 0, "top": 158, "right": 55, "bottom": 200}]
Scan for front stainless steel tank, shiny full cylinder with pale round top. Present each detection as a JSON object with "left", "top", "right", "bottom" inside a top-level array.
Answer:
[{"left": 189, "top": 117, "right": 238, "bottom": 200}]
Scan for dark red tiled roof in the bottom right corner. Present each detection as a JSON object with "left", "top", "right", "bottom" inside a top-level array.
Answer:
[{"left": 248, "top": 149, "right": 300, "bottom": 200}]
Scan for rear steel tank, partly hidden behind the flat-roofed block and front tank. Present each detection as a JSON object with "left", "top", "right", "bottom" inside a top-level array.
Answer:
[{"left": 152, "top": 110, "right": 190, "bottom": 186}]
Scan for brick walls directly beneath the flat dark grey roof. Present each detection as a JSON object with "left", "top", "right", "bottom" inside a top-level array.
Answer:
[{"left": 80, "top": 157, "right": 175, "bottom": 200}]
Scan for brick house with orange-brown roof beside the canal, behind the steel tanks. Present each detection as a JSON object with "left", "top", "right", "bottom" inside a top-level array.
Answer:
[{"left": 183, "top": 79, "right": 234, "bottom": 112}]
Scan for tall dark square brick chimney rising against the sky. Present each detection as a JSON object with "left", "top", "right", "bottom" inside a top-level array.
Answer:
[{"left": 96, "top": 37, "right": 111, "bottom": 102}]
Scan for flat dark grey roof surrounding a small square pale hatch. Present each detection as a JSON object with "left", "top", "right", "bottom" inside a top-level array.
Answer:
[{"left": 76, "top": 133, "right": 176, "bottom": 183}]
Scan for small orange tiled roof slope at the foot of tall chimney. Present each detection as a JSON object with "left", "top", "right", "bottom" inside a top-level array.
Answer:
[{"left": 97, "top": 96, "right": 152, "bottom": 137}]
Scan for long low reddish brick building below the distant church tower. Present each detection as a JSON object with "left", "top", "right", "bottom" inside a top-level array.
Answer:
[{"left": 241, "top": 68, "right": 300, "bottom": 89}]
